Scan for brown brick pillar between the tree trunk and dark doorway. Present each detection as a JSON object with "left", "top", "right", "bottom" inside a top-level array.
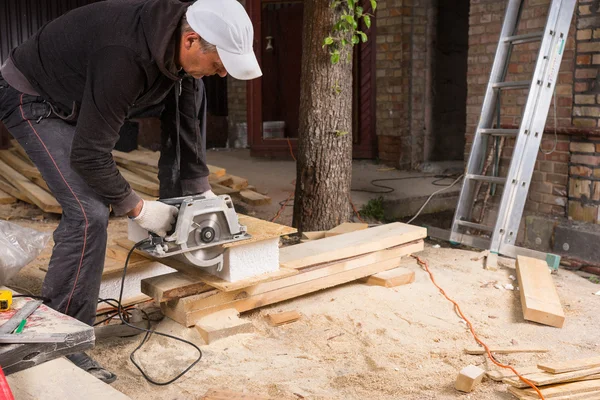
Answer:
[{"left": 375, "top": 0, "right": 432, "bottom": 168}]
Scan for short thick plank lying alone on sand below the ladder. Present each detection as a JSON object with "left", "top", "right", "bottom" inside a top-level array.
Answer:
[{"left": 517, "top": 256, "right": 565, "bottom": 328}]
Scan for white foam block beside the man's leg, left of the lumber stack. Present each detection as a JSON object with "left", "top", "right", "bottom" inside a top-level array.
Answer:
[{"left": 99, "top": 262, "right": 176, "bottom": 299}]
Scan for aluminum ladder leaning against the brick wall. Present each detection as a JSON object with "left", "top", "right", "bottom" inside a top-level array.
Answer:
[{"left": 449, "top": 0, "right": 576, "bottom": 267}]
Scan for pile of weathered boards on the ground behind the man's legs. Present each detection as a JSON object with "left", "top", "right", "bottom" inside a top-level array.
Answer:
[{"left": 0, "top": 140, "right": 271, "bottom": 214}]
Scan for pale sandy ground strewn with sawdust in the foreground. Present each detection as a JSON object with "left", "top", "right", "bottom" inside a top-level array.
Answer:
[{"left": 0, "top": 206, "right": 600, "bottom": 400}]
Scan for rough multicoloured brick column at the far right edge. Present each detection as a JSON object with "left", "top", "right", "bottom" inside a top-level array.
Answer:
[{"left": 569, "top": 1, "right": 600, "bottom": 223}]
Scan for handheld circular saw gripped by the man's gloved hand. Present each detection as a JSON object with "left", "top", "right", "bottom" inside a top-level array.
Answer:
[{"left": 130, "top": 195, "right": 251, "bottom": 271}]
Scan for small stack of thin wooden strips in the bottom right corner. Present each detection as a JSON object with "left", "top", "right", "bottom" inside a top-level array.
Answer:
[{"left": 504, "top": 357, "right": 600, "bottom": 400}]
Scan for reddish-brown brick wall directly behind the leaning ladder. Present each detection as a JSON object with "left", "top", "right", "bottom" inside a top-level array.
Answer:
[{"left": 465, "top": 0, "right": 575, "bottom": 222}]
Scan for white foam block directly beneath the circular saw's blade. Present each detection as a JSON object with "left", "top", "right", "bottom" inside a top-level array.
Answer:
[{"left": 208, "top": 238, "right": 279, "bottom": 282}]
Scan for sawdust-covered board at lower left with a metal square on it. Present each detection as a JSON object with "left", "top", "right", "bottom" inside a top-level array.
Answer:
[{"left": 0, "top": 294, "right": 94, "bottom": 375}]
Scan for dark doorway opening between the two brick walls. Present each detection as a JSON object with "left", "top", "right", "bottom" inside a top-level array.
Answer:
[{"left": 429, "top": 0, "right": 469, "bottom": 161}]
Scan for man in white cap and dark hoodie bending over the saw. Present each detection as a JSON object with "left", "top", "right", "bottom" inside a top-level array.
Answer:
[{"left": 0, "top": 0, "right": 261, "bottom": 382}]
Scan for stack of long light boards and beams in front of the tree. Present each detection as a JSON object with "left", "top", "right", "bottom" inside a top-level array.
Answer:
[{"left": 142, "top": 223, "right": 427, "bottom": 326}]
